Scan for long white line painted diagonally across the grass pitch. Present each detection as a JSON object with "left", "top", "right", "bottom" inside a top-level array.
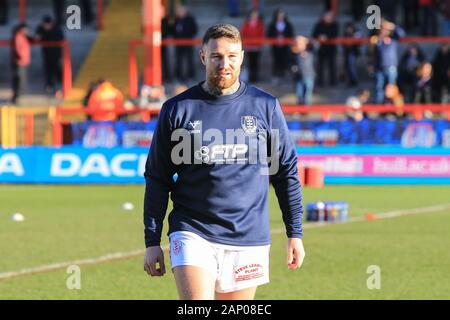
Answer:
[{"left": 0, "top": 204, "right": 450, "bottom": 281}]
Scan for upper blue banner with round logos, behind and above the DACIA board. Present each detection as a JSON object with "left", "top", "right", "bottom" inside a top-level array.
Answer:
[{"left": 72, "top": 119, "right": 450, "bottom": 148}]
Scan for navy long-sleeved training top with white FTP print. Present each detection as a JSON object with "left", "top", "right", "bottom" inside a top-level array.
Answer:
[{"left": 144, "top": 82, "right": 303, "bottom": 247}]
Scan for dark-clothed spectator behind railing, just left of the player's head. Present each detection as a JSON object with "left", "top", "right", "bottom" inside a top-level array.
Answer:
[{"left": 173, "top": 5, "right": 198, "bottom": 82}]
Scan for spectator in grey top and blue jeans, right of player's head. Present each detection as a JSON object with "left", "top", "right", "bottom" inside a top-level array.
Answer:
[{"left": 291, "top": 36, "right": 316, "bottom": 105}]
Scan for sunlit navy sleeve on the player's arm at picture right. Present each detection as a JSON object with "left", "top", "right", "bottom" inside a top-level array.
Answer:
[{"left": 269, "top": 100, "right": 303, "bottom": 238}]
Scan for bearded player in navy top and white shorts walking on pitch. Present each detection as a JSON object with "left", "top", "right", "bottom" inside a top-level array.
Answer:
[{"left": 144, "top": 24, "right": 305, "bottom": 300}]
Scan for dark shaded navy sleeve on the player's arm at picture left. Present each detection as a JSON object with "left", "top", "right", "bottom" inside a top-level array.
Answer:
[{"left": 144, "top": 105, "right": 175, "bottom": 247}]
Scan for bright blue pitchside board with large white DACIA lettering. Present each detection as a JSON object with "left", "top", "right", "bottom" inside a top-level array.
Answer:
[{"left": 0, "top": 147, "right": 148, "bottom": 183}]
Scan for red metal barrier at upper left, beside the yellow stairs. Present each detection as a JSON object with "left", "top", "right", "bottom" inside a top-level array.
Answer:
[{"left": 0, "top": 40, "right": 72, "bottom": 97}]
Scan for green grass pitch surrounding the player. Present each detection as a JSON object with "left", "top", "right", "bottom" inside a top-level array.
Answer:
[{"left": 0, "top": 185, "right": 450, "bottom": 300}]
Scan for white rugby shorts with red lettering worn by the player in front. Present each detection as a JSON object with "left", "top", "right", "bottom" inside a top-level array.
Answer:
[{"left": 169, "top": 231, "right": 270, "bottom": 293}]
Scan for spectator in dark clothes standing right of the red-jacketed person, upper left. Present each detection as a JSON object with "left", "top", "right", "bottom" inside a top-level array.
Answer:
[{"left": 35, "top": 15, "right": 64, "bottom": 94}]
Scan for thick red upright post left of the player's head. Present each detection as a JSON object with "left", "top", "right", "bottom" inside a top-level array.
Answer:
[{"left": 142, "top": 0, "right": 163, "bottom": 86}]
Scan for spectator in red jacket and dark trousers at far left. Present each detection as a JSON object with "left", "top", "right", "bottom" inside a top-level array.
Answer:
[{"left": 11, "top": 23, "right": 32, "bottom": 104}]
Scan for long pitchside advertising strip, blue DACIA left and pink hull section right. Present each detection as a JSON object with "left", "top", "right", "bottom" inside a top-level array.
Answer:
[{"left": 0, "top": 146, "right": 450, "bottom": 184}]
